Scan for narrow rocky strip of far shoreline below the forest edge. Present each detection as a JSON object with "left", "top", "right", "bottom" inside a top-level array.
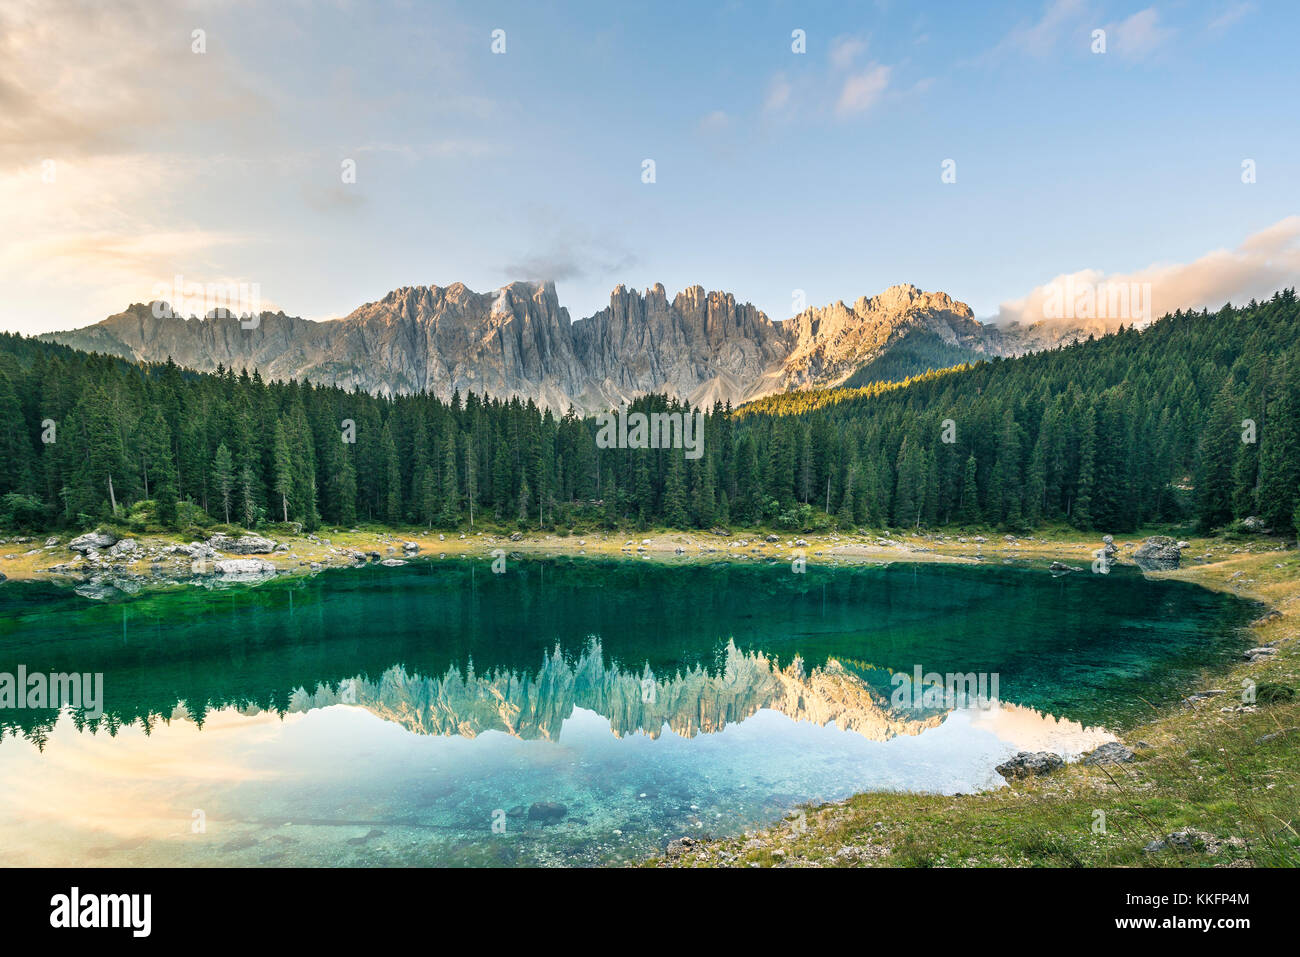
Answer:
[{"left": 0, "top": 528, "right": 1268, "bottom": 598}]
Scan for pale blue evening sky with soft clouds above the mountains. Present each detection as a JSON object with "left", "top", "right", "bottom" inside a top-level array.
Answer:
[{"left": 0, "top": 0, "right": 1300, "bottom": 334}]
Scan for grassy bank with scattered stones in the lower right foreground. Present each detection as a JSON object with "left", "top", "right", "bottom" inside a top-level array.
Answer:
[{"left": 660, "top": 540, "right": 1300, "bottom": 867}]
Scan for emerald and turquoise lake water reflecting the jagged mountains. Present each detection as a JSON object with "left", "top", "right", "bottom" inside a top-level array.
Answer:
[{"left": 0, "top": 559, "right": 1252, "bottom": 865}]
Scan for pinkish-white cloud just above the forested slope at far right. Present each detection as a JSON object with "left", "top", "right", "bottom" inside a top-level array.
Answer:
[{"left": 993, "top": 216, "right": 1300, "bottom": 333}]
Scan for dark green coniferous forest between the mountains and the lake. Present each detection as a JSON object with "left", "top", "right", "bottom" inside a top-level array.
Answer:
[{"left": 0, "top": 289, "right": 1300, "bottom": 532}]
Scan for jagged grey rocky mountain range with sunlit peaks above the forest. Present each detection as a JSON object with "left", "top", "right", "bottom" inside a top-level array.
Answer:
[{"left": 42, "top": 282, "right": 1060, "bottom": 412}]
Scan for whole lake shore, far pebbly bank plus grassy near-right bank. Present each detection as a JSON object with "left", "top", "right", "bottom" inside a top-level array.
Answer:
[{"left": 0, "top": 528, "right": 1300, "bottom": 866}]
